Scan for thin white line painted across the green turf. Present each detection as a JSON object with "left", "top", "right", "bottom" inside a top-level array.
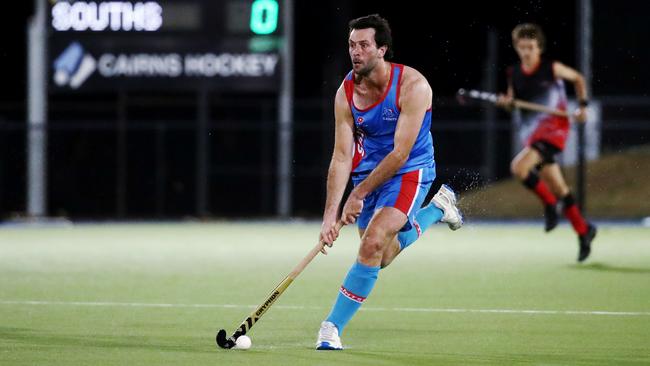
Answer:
[{"left": 0, "top": 300, "right": 650, "bottom": 316}]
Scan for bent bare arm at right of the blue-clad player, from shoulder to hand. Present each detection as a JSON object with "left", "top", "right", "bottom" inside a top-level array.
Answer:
[{"left": 341, "top": 67, "right": 433, "bottom": 224}]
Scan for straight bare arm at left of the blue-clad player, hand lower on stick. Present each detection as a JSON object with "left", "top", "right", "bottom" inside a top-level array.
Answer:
[{"left": 320, "top": 84, "right": 354, "bottom": 246}]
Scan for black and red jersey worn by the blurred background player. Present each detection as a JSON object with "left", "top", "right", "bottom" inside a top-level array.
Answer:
[{"left": 508, "top": 59, "right": 569, "bottom": 150}]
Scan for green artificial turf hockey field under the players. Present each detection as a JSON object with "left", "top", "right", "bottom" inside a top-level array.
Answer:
[{"left": 0, "top": 223, "right": 650, "bottom": 366}]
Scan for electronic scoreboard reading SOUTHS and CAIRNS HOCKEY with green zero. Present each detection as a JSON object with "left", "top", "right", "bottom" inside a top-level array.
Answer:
[{"left": 47, "top": 0, "right": 283, "bottom": 93}]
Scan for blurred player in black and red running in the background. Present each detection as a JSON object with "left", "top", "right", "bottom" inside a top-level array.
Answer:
[{"left": 497, "top": 24, "right": 596, "bottom": 262}]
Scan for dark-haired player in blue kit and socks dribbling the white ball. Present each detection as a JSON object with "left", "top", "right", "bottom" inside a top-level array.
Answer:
[{"left": 316, "top": 15, "right": 463, "bottom": 350}]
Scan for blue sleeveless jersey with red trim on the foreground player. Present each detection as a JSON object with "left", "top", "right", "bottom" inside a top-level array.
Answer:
[{"left": 344, "top": 64, "right": 435, "bottom": 177}]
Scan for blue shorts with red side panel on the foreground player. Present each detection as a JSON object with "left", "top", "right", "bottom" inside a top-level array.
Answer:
[{"left": 352, "top": 168, "right": 436, "bottom": 231}]
